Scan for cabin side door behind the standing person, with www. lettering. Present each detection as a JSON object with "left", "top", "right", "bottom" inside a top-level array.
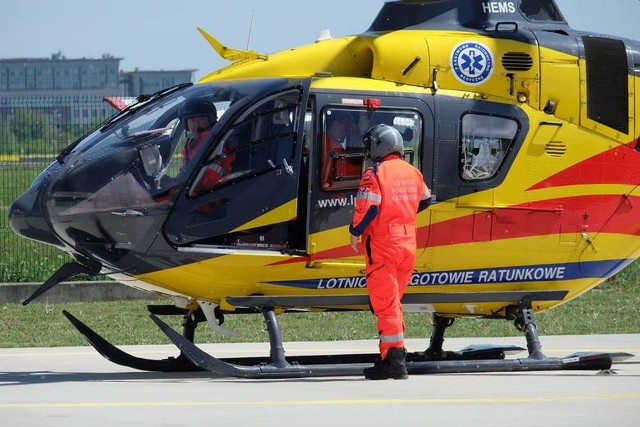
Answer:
[{"left": 307, "top": 91, "right": 434, "bottom": 266}]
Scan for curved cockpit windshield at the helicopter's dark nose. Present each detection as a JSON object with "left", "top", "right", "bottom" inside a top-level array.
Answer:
[{"left": 48, "top": 79, "right": 288, "bottom": 214}]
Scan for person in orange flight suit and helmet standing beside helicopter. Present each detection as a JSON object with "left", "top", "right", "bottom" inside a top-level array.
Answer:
[{"left": 349, "top": 124, "right": 431, "bottom": 380}]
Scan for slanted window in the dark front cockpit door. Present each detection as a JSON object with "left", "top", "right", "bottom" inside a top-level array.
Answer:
[{"left": 189, "top": 91, "right": 300, "bottom": 197}]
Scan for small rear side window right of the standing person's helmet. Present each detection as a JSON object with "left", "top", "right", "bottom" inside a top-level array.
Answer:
[{"left": 460, "top": 114, "right": 518, "bottom": 181}]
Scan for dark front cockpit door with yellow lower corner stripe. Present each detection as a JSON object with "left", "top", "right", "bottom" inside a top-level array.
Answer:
[{"left": 165, "top": 86, "right": 306, "bottom": 251}]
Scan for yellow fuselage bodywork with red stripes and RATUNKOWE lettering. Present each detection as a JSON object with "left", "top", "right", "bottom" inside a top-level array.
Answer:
[{"left": 125, "top": 23, "right": 640, "bottom": 315}]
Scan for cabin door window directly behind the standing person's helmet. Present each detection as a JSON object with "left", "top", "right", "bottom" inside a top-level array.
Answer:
[{"left": 320, "top": 108, "right": 422, "bottom": 191}]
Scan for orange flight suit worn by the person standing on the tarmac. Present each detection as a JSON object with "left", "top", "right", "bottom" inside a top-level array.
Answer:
[{"left": 349, "top": 154, "right": 430, "bottom": 359}]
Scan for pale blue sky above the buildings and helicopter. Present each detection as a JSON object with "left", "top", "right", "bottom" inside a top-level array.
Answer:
[{"left": 0, "top": 0, "right": 640, "bottom": 79}]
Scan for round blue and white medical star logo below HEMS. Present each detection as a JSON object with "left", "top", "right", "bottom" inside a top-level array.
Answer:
[{"left": 451, "top": 42, "right": 494, "bottom": 86}]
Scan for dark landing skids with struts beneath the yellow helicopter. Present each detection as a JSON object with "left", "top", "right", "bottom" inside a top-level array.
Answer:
[{"left": 63, "top": 300, "right": 633, "bottom": 379}]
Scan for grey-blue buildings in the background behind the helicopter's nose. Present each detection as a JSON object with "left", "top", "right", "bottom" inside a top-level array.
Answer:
[{"left": 0, "top": 52, "right": 196, "bottom": 128}]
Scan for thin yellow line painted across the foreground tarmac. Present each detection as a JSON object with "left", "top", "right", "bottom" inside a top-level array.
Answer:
[{"left": 0, "top": 393, "right": 640, "bottom": 409}]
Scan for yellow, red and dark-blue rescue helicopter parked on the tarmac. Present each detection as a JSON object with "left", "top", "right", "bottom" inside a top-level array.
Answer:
[{"left": 9, "top": 0, "right": 640, "bottom": 378}]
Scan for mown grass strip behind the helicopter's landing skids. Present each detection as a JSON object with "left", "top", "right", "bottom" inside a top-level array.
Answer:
[{"left": 0, "top": 272, "right": 640, "bottom": 348}]
